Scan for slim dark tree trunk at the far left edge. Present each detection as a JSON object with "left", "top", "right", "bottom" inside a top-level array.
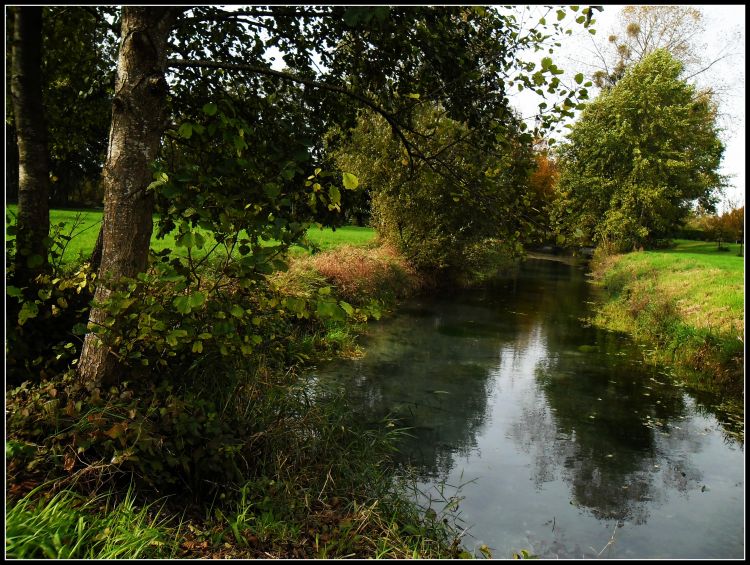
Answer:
[{"left": 11, "top": 6, "right": 49, "bottom": 286}]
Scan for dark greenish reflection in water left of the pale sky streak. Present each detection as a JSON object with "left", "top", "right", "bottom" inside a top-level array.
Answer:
[{"left": 316, "top": 295, "right": 518, "bottom": 477}]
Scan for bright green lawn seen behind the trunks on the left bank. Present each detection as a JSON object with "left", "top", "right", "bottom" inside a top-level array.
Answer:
[{"left": 6, "top": 204, "right": 375, "bottom": 264}]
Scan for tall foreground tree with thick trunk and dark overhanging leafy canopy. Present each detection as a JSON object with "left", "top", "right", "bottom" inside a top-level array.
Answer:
[{"left": 79, "top": 6, "right": 592, "bottom": 383}]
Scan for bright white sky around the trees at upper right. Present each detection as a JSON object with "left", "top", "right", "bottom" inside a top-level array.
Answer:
[{"left": 511, "top": 5, "right": 745, "bottom": 213}]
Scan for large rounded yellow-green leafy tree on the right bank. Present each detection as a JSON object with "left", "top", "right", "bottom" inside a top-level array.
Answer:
[{"left": 555, "top": 51, "right": 723, "bottom": 250}]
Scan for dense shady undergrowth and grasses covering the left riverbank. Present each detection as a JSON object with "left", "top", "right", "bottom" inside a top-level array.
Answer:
[{"left": 6, "top": 226, "right": 476, "bottom": 558}]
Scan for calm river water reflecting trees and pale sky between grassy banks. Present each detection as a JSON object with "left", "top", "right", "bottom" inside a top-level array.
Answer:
[{"left": 306, "top": 259, "right": 745, "bottom": 559}]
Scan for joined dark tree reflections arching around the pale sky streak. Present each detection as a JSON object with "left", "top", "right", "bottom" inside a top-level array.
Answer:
[{"left": 316, "top": 262, "right": 736, "bottom": 524}]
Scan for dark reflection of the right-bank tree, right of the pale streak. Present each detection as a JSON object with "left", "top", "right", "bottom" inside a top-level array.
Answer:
[{"left": 511, "top": 262, "right": 712, "bottom": 524}]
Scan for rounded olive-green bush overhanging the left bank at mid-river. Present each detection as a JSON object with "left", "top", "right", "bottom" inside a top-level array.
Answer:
[{"left": 334, "top": 105, "right": 533, "bottom": 275}]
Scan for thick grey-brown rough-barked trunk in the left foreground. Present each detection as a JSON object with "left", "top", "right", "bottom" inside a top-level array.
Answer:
[{"left": 78, "top": 6, "right": 181, "bottom": 386}]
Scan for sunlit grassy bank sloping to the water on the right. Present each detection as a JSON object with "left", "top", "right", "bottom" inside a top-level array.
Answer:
[{"left": 592, "top": 240, "right": 745, "bottom": 397}]
